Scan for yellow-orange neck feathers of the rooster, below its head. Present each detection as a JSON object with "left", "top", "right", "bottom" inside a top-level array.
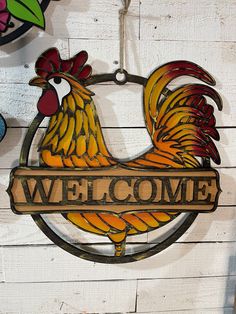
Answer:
[{"left": 40, "top": 89, "right": 114, "bottom": 167}]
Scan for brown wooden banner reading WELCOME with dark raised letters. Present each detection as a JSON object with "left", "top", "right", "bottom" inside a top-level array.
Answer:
[{"left": 8, "top": 168, "right": 220, "bottom": 214}]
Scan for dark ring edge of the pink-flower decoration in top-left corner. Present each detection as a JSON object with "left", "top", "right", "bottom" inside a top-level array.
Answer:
[{"left": 0, "top": 0, "right": 51, "bottom": 46}]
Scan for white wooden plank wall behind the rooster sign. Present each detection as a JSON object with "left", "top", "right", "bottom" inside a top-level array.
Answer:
[{"left": 0, "top": 0, "right": 236, "bottom": 314}]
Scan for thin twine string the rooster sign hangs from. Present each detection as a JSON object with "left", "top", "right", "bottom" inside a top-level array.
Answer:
[{"left": 119, "top": 0, "right": 131, "bottom": 73}]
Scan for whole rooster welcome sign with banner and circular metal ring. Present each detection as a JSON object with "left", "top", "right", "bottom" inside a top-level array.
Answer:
[{"left": 8, "top": 48, "right": 222, "bottom": 263}]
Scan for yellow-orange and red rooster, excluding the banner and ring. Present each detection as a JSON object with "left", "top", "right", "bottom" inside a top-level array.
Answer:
[{"left": 30, "top": 48, "right": 222, "bottom": 256}]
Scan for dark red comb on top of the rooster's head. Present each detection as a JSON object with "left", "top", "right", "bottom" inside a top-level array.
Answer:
[{"left": 35, "top": 48, "right": 92, "bottom": 81}]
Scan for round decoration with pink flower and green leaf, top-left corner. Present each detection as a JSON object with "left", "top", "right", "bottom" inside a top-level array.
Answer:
[{"left": 0, "top": 0, "right": 58, "bottom": 45}]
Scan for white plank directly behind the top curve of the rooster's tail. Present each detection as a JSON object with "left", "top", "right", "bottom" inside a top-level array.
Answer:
[{"left": 139, "top": 40, "right": 236, "bottom": 88}]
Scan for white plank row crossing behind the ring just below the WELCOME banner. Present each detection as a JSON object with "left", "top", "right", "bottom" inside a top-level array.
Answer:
[{"left": 0, "top": 207, "right": 236, "bottom": 250}]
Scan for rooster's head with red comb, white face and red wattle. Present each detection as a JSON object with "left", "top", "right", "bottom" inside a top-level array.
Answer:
[{"left": 29, "top": 48, "right": 93, "bottom": 117}]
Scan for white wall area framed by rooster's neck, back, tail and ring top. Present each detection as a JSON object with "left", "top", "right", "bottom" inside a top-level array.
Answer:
[{"left": 90, "top": 84, "right": 152, "bottom": 161}]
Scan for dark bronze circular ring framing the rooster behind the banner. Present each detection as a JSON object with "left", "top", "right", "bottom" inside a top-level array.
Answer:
[{"left": 20, "top": 71, "right": 198, "bottom": 264}]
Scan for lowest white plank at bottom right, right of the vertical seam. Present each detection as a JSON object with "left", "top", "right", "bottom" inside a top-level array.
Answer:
[{"left": 137, "top": 277, "right": 236, "bottom": 313}]
